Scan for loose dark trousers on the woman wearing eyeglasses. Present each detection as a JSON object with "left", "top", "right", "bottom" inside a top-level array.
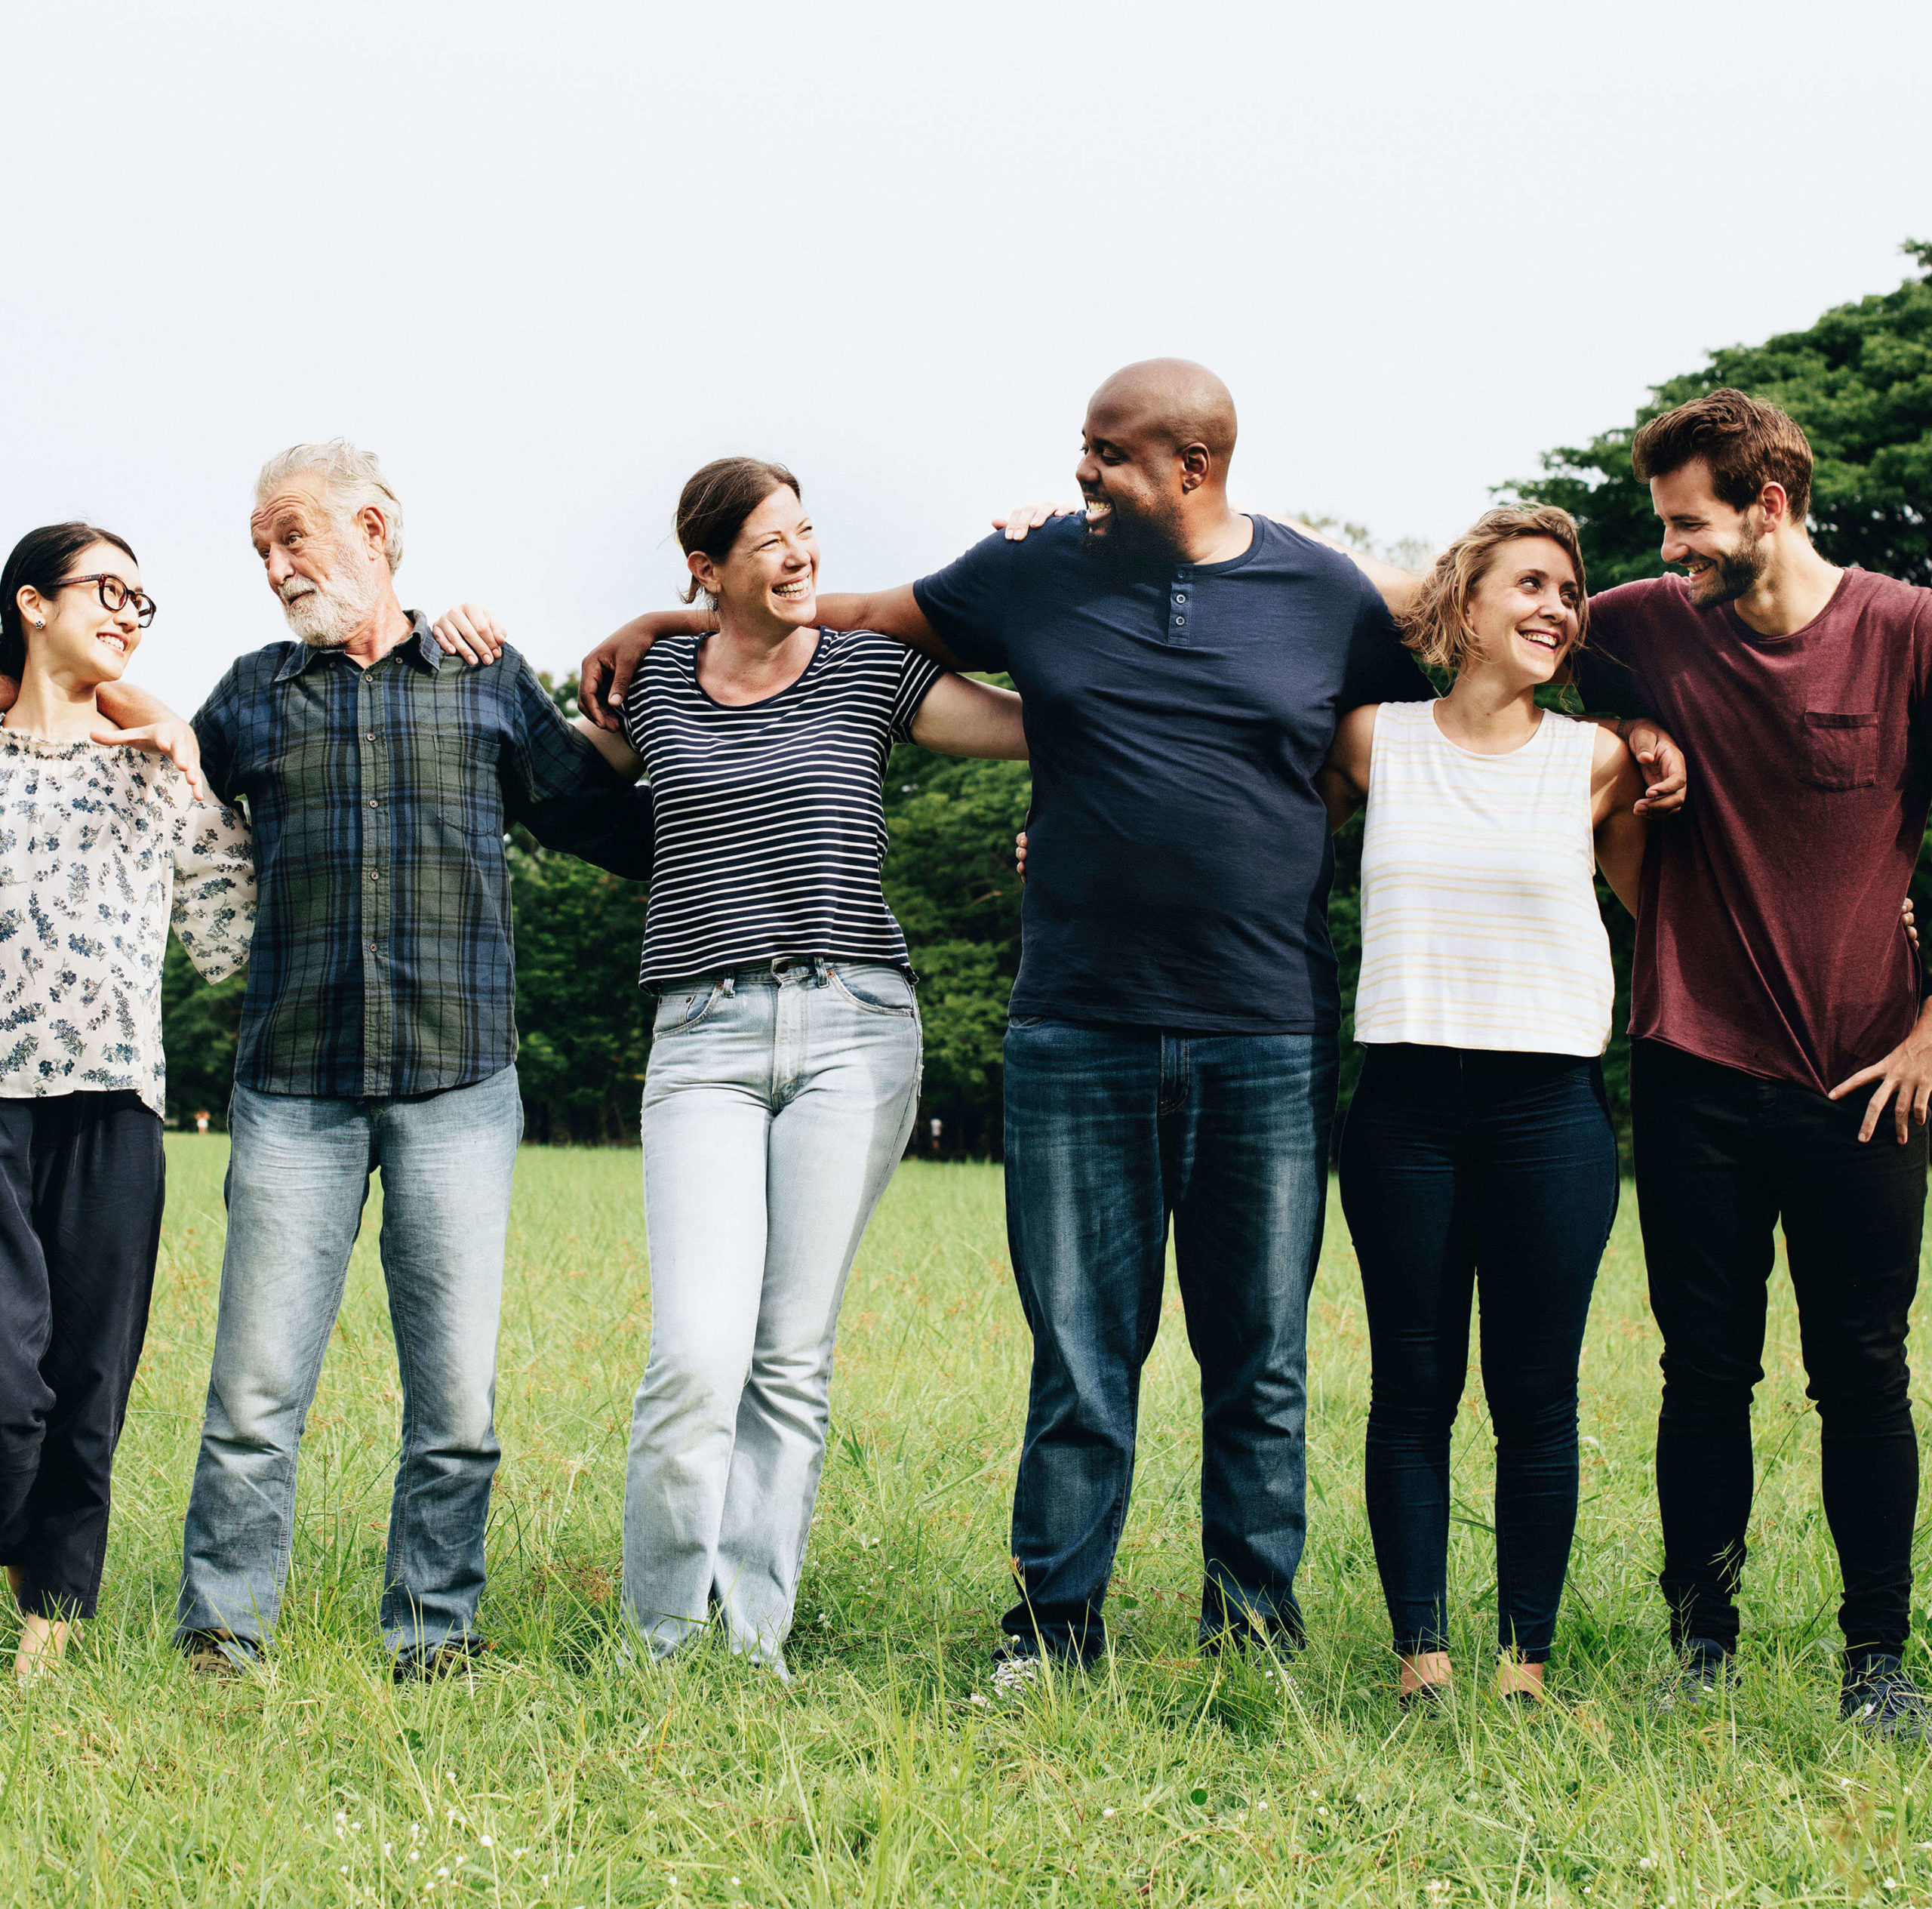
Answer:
[{"left": 0, "top": 1094, "right": 165, "bottom": 1617}]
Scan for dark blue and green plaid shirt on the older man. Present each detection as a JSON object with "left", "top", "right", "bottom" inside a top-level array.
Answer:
[{"left": 195, "top": 611, "right": 651, "bottom": 1099}]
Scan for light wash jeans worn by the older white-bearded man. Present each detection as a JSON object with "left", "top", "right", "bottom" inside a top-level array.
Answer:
[{"left": 176, "top": 1067, "right": 524, "bottom": 1654}]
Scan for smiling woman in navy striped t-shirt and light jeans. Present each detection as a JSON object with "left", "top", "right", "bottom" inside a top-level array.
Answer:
[{"left": 580, "top": 458, "right": 1026, "bottom": 1675}]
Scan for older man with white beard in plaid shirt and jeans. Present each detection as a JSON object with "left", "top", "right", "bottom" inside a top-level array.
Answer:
[{"left": 176, "top": 441, "right": 649, "bottom": 1681}]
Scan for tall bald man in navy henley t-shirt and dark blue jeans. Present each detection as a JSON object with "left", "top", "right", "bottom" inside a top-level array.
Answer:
[{"left": 582, "top": 358, "right": 1432, "bottom": 1689}]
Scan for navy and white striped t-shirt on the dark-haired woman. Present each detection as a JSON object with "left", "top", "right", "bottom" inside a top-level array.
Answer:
[{"left": 624, "top": 630, "right": 943, "bottom": 987}]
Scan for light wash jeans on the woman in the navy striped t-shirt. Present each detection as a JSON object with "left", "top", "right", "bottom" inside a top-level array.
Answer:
[{"left": 624, "top": 960, "right": 920, "bottom": 1675}]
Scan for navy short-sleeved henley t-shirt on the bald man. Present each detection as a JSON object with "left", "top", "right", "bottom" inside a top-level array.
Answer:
[{"left": 912, "top": 516, "right": 1435, "bottom": 1033}]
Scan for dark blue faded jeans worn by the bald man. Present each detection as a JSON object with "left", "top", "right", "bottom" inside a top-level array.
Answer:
[{"left": 1001, "top": 1018, "right": 1335, "bottom": 1661}]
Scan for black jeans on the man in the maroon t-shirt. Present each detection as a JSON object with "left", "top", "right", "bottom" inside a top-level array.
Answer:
[{"left": 1631, "top": 1042, "right": 1926, "bottom": 1660}]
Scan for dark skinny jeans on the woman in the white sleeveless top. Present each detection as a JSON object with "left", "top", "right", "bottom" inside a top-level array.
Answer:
[{"left": 1341, "top": 1045, "right": 1617, "bottom": 1664}]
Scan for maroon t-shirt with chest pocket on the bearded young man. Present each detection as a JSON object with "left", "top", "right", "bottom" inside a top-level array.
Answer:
[{"left": 1577, "top": 570, "right": 1932, "bottom": 1092}]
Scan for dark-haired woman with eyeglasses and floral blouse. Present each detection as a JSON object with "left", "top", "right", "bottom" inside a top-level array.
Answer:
[{"left": 0, "top": 524, "right": 255, "bottom": 1681}]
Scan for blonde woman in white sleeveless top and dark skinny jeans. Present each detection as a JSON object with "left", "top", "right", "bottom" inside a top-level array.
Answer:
[{"left": 1329, "top": 508, "right": 1644, "bottom": 1708}]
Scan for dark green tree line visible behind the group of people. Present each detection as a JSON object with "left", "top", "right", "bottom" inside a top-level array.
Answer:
[{"left": 162, "top": 242, "right": 1932, "bottom": 1156}]
